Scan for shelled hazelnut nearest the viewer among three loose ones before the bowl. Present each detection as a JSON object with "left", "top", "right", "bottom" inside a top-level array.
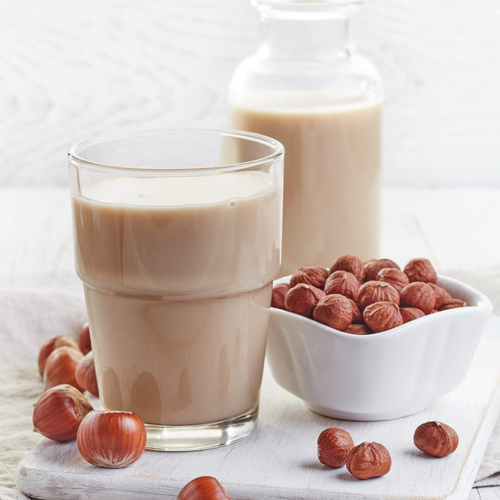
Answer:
[{"left": 346, "top": 442, "right": 392, "bottom": 479}]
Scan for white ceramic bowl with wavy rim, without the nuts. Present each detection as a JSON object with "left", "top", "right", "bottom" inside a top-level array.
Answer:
[{"left": 267, "top": 276, "right": 493, "bottom": 421}]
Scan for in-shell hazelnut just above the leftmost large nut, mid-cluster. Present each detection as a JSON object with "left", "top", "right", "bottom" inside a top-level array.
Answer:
[{"left": 43, "top": 346, "right": 83, "bottom": 392}]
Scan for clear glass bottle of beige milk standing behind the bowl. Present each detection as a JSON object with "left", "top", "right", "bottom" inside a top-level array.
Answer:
[{"left": 229, "top": 0, "right": 383, "bottom": 276}]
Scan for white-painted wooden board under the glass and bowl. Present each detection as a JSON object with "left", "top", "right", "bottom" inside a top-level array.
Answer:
[{"left": 17, "top": 317, "right": 500, "bottom": 500}]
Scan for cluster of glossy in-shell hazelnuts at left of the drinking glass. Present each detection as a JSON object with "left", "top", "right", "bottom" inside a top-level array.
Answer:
[{"left": 33, "top": 323, "right": 146, "bottom": 468}]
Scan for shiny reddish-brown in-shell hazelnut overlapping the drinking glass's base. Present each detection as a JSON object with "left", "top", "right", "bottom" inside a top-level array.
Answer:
[{"left": 76, "top": 410, "right": 147, "bottom": 469}]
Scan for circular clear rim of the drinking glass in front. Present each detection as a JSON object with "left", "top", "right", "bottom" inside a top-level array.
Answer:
[{"left": 67, "top": 128, "right": 285, "bottom": 175}]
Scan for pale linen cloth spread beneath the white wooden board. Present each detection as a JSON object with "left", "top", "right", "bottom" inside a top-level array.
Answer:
[{"left": 0, "top": 286, "right": 500, "bottom": 500}]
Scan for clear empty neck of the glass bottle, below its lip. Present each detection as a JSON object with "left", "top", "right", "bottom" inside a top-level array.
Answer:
[{"left": 259, "top": 16, "right": 353, "bottom": 61}]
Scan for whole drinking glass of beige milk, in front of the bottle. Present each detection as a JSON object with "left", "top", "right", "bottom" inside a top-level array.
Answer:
[{"left": 68, "top": 130, "right": 284, "bottom": 451}]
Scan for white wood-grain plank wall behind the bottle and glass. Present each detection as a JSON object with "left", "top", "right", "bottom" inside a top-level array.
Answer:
[{"left": 0, "top": 0, "right": 500, "bottom": 187}]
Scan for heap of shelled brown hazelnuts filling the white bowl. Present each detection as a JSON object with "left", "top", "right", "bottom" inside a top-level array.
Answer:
[{"left": 271, "top": 255, "right": 467, "bottom": 335}]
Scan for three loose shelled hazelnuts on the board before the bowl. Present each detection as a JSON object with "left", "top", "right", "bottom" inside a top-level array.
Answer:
[{"left": 317, "top": 421, "right": 458, "bottom": 479}]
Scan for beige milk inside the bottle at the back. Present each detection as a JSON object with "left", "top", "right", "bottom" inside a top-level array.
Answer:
[{"left": 230, "top": 93, "right": 381, "bottom": 276}]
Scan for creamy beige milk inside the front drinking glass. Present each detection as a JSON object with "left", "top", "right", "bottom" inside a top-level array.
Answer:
[{"left": 73, "top": 171, "right": 281, "bottom": 425}]
